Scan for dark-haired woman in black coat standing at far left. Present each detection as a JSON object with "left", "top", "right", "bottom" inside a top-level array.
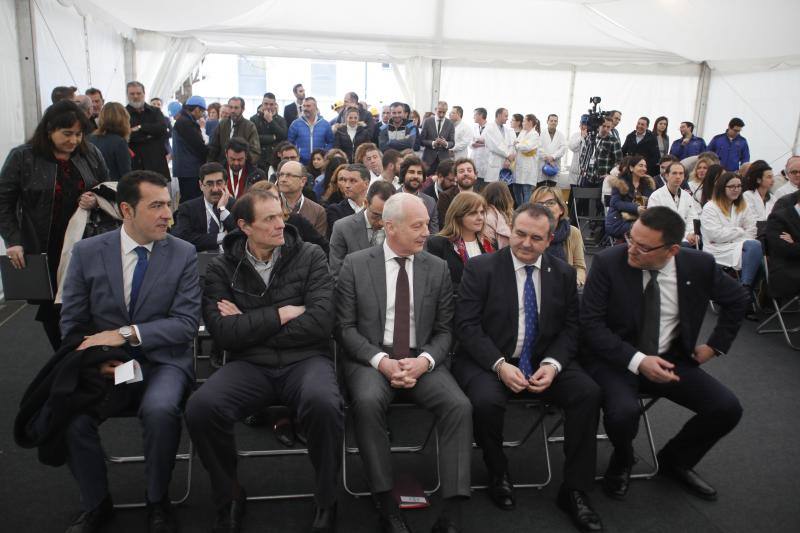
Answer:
[{"left": 0, "top": 100, "right": 108, "bottom": 349}]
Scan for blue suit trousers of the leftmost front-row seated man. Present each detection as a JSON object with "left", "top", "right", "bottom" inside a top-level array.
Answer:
[{"left": 66, "top": 364, "right": 189, "bottom": 511}]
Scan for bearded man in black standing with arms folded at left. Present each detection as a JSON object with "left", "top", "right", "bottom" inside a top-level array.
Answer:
[{"left": 125, "top": 81, "right": 170, "bottom": 179}]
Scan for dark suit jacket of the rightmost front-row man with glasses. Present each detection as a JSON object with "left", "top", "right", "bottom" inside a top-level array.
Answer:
[{"left": 580, "top": 246, "right": 749, "bottom": 371}]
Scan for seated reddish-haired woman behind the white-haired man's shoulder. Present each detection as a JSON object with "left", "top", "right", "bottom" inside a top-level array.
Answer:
[{"left": 425, "top": 191, "right": 494, "bottom": 293}]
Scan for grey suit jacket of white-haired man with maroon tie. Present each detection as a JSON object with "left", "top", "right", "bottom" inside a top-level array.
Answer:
[{"left": 336, "top": 246, "right": 453, "bottom": 365}]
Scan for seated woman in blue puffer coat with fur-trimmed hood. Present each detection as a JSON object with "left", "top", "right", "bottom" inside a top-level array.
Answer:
[{"left": 606, "top": 155, "right": 655, "bottom": 239}]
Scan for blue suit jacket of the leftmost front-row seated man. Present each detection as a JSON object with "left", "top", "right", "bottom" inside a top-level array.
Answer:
[{"left": 61, "top": 230, "right": 200, "bottom": 379}]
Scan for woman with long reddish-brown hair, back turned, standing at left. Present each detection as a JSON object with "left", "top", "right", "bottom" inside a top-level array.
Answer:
[{"left": 89, "top": 102, "right": 131, "bottom": 181}]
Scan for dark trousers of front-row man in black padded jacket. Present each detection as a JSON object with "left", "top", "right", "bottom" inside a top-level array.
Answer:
[{"left": 186, "top": 355, "right": 344, "bottom": 507}]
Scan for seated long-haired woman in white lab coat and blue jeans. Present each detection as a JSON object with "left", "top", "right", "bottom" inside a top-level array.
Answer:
[{"left": 700, "top": 172, "right": 764, "bottom": 291}]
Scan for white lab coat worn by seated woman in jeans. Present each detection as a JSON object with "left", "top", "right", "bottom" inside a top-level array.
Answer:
[{"left": 700, "top": 201, "right": 756, "bottom": 270}]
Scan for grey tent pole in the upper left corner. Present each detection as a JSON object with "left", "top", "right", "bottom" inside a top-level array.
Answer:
[{"left": 14, "top": 0, "right": 42, "bottom": 139}]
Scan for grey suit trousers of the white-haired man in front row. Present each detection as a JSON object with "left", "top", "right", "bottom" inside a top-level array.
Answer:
[{"left": 345, "top": 362, "right": 472, "bottom": 498}]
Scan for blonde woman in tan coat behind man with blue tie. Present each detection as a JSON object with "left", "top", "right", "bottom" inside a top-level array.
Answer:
[{"left": 531, "top": 186, "right": 586, "bottom": 287}]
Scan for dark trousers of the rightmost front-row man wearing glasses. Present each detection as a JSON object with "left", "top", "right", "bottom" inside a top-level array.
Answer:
[{"left": 587, "top": 358, "right": 742, "bottom": 468}]
